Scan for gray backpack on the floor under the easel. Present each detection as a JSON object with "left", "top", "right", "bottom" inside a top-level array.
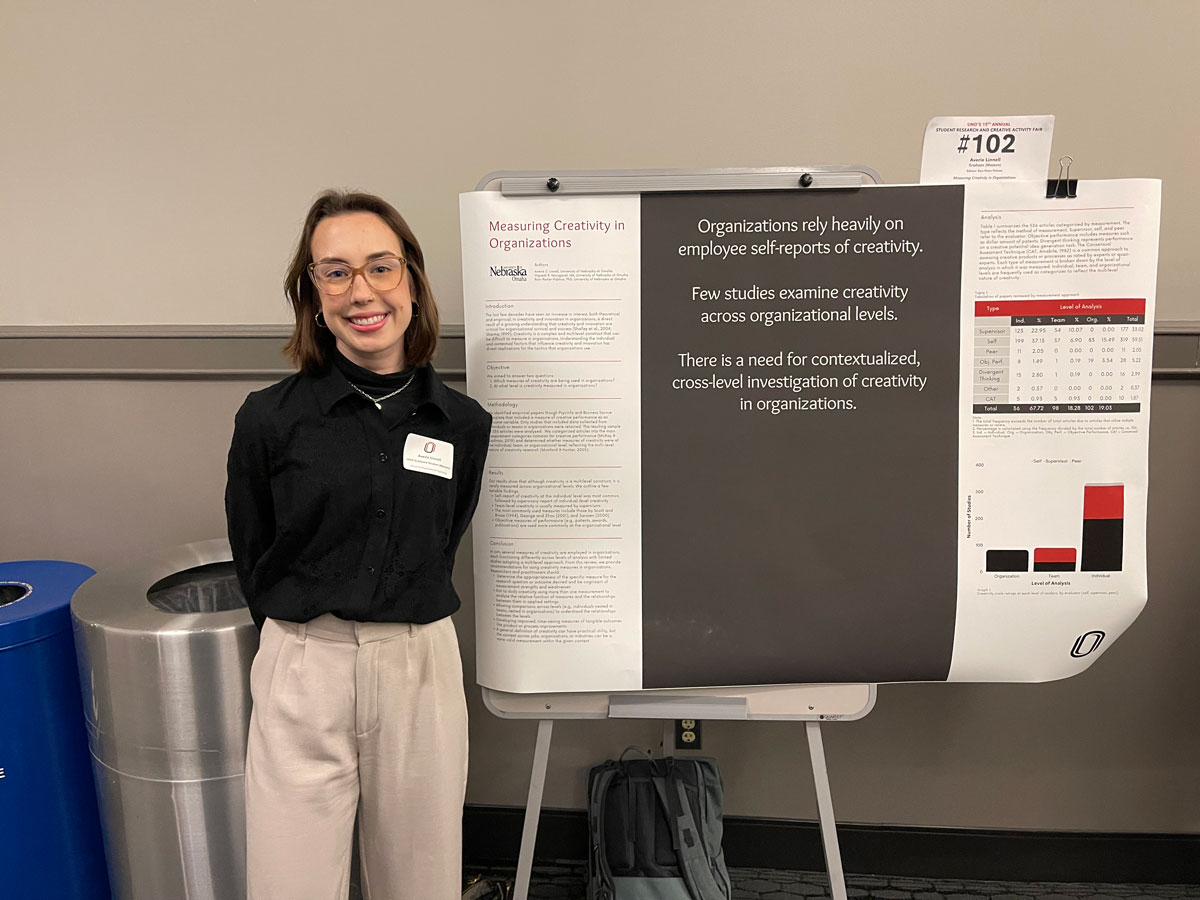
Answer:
[{"left": 588, "top": 754, "right": 732, "bottom": 900}]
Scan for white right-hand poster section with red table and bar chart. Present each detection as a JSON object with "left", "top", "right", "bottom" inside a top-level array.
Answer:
[{"left": 949, "top": 180, "right": 1160, "bottom": 682}]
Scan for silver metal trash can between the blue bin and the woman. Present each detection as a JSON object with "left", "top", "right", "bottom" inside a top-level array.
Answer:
[{"left": 71, "top": 540, "right": 258, "bottom": 900}]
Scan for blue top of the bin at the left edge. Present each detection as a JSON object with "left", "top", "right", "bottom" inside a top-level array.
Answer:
[{"left": 0, "top": 559, "right": 96, "bottom": 650}]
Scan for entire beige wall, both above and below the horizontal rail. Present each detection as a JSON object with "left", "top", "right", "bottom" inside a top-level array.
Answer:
[{"left": 0, "top": 0, "right": 1200, "bottom": 832}]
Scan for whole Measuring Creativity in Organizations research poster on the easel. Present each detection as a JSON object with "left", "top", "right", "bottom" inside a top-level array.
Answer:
[{"left": 461, "top": 181, "right": 1158, "bottom": 692}]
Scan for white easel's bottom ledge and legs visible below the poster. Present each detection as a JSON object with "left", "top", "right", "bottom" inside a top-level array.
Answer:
[{"left": 482, "top": 684, "right": 876, "bottom": 900}]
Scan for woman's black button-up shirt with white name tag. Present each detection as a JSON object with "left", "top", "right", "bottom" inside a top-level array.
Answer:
[{"left": 226, "top": 366, "right": 492, "bottom": 628}]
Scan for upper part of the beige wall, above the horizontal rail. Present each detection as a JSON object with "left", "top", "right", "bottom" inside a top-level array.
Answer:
[{"left": 0, "top": 0, "right": 1200, "bottom": 325}]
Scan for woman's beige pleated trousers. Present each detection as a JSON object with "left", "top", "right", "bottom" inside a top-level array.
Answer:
[{"left": 246, "top": 614, "right": 467, "bottom": 900}]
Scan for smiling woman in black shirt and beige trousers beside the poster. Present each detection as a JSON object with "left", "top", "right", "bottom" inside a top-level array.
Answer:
[{"left": 226, "top": 191, "right": 491, "bottom": 900}]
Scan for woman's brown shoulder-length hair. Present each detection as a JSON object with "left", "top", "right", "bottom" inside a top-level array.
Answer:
[{"left": 283, "top": 191, "right": 438, "bottom": 372}]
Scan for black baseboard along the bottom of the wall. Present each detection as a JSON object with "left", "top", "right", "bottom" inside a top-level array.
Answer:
[{"left": 463, "top": 805, "right": 1200, "bottom": 884}]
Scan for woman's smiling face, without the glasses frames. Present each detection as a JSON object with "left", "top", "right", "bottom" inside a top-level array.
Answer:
[{"left": 312, "top": 212, "right": 413, "bottom": 374}]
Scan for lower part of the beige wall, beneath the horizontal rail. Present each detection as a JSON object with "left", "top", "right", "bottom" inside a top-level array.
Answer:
[{"left": 0, "top": 380, "right": 1200, "bottom": 833}]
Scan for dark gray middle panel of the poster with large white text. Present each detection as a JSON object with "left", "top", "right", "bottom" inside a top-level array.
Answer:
[{"left": 642, "top": 186, "right": 964, "bottom": 688}]
